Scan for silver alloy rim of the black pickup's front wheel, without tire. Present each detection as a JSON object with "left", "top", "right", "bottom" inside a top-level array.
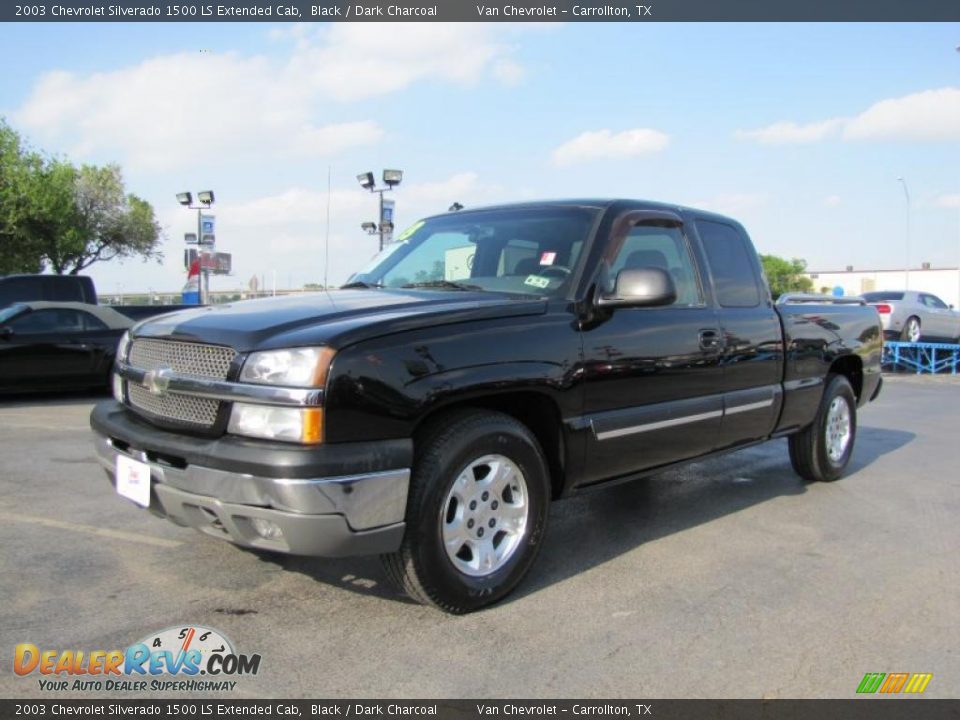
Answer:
[{"left": 440, "top": 455, "right": 530, "bottom": 577}]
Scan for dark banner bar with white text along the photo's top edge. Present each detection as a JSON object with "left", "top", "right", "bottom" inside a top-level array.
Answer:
[{"left": 0, "top": 0, "right": 960, "bottom": 22}]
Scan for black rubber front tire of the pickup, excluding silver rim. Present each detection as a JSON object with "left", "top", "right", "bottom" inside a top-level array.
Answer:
[{"left": 408, "top": 419, "right": 550, "bottom": 611}]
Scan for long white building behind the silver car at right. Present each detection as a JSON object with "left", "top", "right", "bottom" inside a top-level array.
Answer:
[{"left": 807, "top": 263, "right": 960, "bottom": 307}]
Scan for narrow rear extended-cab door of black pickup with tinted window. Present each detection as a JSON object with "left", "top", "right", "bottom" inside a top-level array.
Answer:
[{"left": 695, "top": 217, "right": 783, "bottom": 447}]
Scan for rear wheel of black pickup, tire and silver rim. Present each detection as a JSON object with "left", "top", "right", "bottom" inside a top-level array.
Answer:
[{"left": 789, "top": 375, "right": 857, "bottom": 482}]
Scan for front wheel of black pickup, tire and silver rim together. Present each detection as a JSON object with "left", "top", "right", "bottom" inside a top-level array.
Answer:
[{"left": 382, "top": 411, "right": 550, "bottom": 614}]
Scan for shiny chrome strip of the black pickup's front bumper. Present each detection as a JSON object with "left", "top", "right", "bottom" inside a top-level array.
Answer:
[{"left": 95, "top": 433, "right": 410, "bottom": 530}]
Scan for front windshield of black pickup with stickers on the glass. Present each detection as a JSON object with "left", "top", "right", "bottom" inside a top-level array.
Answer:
[{"left": 347, "top": 207, "right": 598, "bottom": 296}]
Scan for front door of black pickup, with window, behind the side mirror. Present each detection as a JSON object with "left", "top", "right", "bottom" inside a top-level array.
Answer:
[{"left": 582, "top": 211, "right": 723, "bottom": 483}]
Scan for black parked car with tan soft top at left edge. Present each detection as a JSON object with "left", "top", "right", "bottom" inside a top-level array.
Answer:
[{"left": 0, "top": 301, "right": 133, "bottom": 393}]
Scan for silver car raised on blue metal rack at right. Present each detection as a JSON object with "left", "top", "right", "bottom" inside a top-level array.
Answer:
[{"left": 863, "top": 290, "right": 960, "bottom": 344}]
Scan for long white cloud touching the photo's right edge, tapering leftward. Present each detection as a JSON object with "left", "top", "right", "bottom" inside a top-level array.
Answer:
[{"left": 734, "top": 87, "right": 960, "bottom": 145}]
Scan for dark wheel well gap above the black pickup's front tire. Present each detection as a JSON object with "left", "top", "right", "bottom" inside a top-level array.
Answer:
[{"left": 413, "top": 392, "right": 565, "bottom": 498}]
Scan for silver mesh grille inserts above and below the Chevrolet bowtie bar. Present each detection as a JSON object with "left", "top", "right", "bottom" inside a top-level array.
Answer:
[{"left": 127, "top": 338, "right": 236, "bottom": 428}]
